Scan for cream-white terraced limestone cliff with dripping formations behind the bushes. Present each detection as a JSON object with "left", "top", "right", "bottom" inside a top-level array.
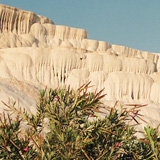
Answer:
[{"left": 0, "top": 5, "right": 160, "bottom": 132}]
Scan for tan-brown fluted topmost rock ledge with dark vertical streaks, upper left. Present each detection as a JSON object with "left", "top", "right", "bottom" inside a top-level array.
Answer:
[{"left": 0, "top": 4, "right": 53, "bottom": 34}]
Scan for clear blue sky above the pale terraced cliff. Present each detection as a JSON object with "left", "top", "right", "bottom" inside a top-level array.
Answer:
[{"left": 0, "top": 0, "right": 160, "bottom": 53}]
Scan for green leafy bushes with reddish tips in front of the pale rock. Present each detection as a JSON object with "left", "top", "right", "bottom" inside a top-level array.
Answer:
[{"left": 0, "top": 84, "right": 160, "bottom": 160}]
